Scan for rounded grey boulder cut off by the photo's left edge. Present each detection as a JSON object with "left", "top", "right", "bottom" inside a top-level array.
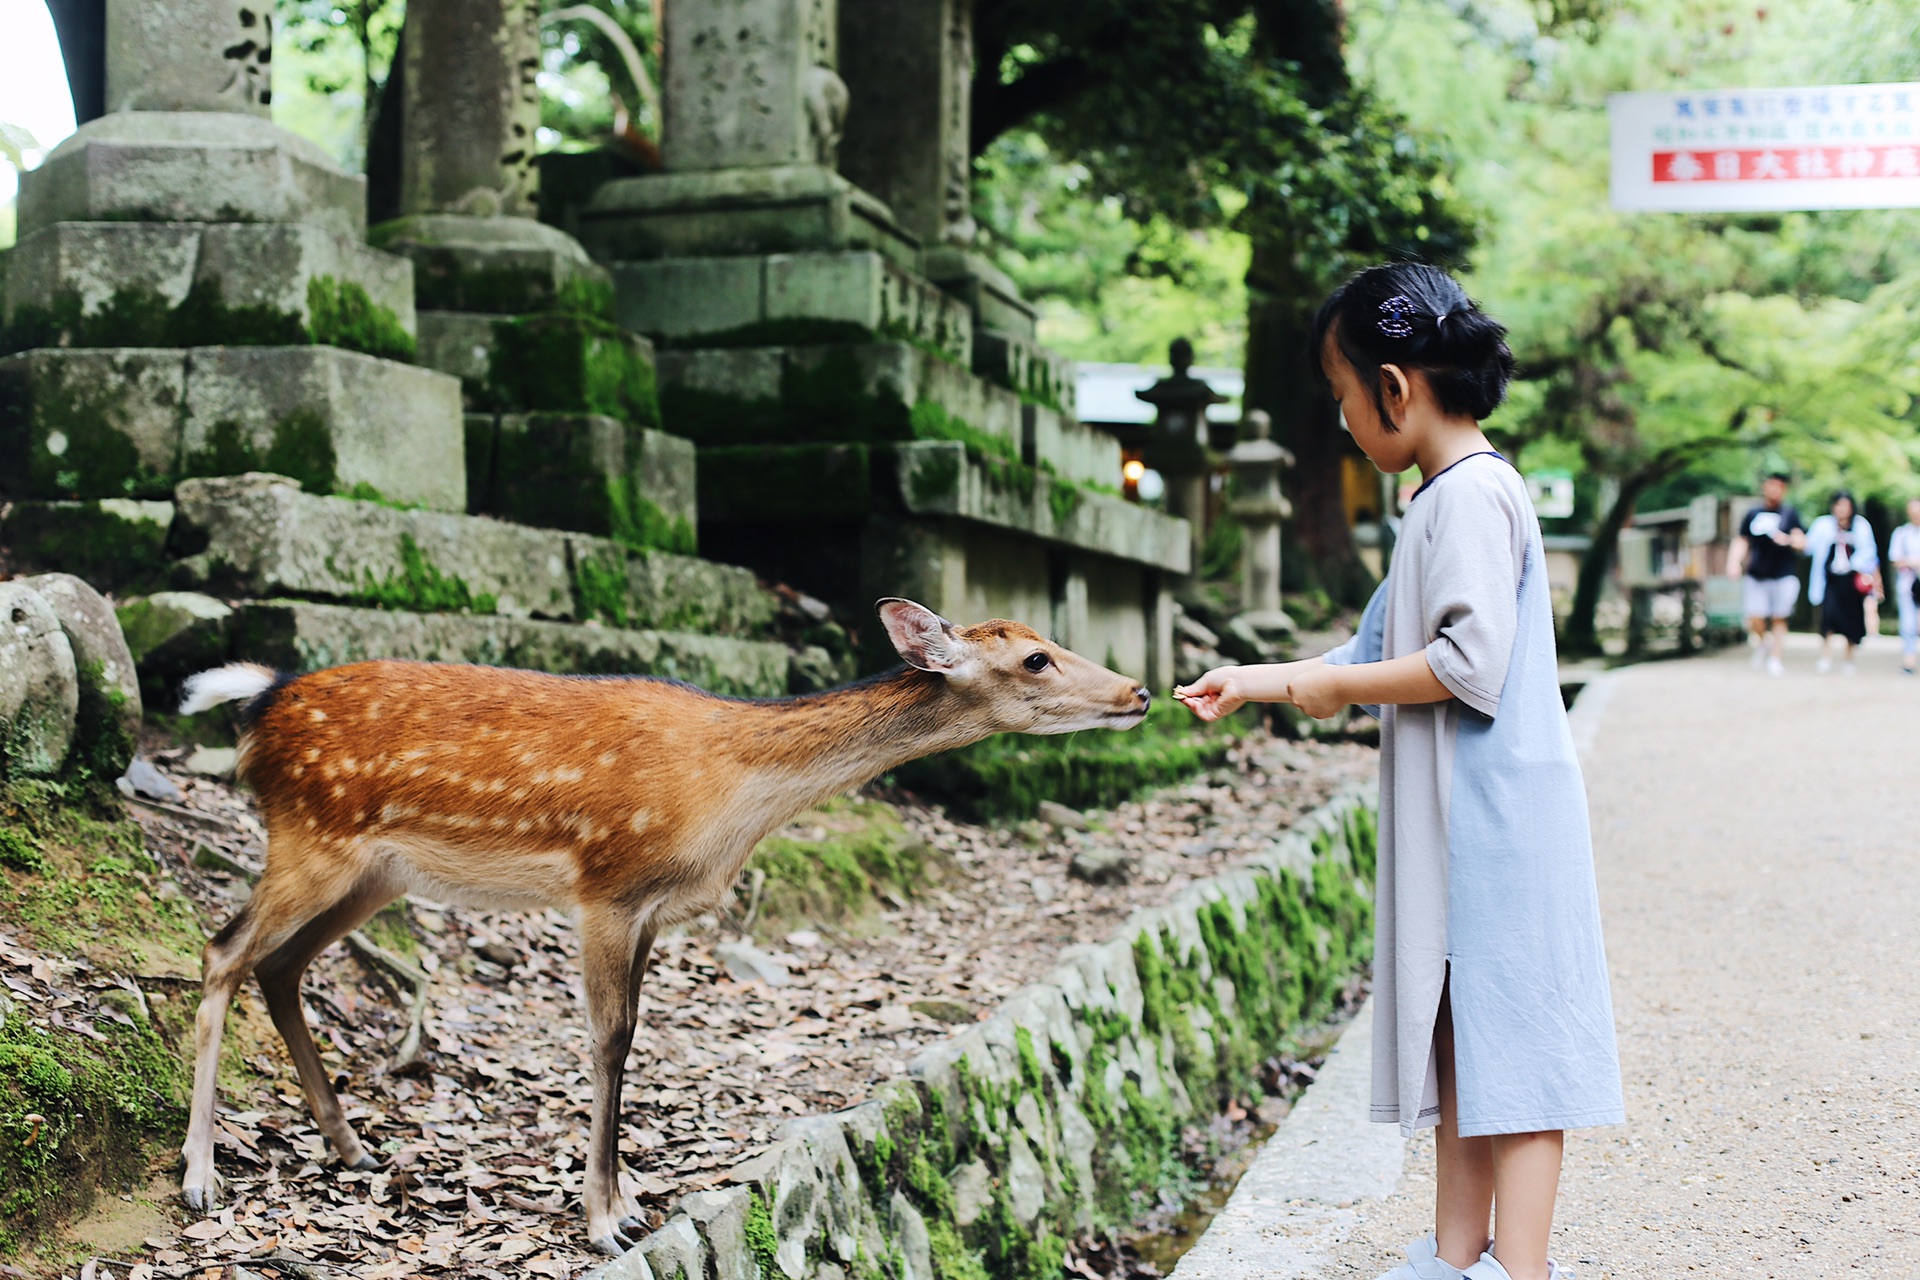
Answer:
[{"left": 0, "top": 581, "right": 81, "bottom": 777}]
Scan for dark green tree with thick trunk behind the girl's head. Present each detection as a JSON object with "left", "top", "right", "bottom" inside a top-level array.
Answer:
[{"left": 973, "top": 0, "right": 1473, "bottom": 599}]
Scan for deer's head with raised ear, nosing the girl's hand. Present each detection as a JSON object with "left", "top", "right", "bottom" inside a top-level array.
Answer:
[{"left": 879, "top": 599, "right": 1152, "bottom": 733}]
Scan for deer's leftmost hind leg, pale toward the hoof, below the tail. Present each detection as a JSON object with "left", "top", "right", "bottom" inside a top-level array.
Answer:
[{"left": 180, "top": 832, "right": 385, "bottom": 1211}]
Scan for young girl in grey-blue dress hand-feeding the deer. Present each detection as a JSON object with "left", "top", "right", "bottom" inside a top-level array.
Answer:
[{"left": 1175, "top": 263, "right": 1624, "bottom": 1280}]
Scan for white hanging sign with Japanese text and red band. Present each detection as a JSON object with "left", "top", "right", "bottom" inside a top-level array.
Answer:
[{"left": 1607, "top": 83, "right": 1920, "bottom": 213}]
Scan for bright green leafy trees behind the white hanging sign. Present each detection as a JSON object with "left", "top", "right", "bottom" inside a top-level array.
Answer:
[{"left": 1356, "top": 0, "right": 1920, "bottom": 645}]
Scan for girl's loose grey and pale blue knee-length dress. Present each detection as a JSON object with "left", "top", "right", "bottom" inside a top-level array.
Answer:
[{"left": 1327, "top": 453, "right": 1626, "bottom": 1138}]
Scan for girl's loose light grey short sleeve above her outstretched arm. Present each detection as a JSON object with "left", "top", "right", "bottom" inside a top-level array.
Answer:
[{"left": 1421, "top": 476, "right": 1528, "bottom": 716}]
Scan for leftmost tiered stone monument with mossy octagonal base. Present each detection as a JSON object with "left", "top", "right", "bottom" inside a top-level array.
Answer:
[{"left": 0, "top": 0, "right": 467, "bottom": 510}]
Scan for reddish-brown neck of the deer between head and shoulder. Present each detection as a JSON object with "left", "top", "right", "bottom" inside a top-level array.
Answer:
[{"left": 730, "top": 668, "right": 993, "bottom": 808}]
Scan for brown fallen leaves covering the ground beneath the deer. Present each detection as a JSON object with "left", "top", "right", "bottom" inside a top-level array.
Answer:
[{"left": 52, "top": 737, "right": 1375, "bottom": 1280}]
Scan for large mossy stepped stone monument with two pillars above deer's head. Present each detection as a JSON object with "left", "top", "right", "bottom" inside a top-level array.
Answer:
[{"left": 578, "top": 0, "right": 1190, "bottom": 687}]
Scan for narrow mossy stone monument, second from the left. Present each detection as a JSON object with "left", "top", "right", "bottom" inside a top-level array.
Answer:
[{"left": 372, "top": 0, "right": 697, "bottom": 551}]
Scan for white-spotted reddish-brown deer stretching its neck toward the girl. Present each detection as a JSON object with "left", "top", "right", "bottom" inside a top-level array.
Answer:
[{"left": 180, "top": 597, "right": 1152, "bottom": 1255}]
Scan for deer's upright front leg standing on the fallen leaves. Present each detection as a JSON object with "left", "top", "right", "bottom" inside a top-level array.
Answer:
[{"left": 580, "top": 908, "right": 653, "bottom": 1257}]
